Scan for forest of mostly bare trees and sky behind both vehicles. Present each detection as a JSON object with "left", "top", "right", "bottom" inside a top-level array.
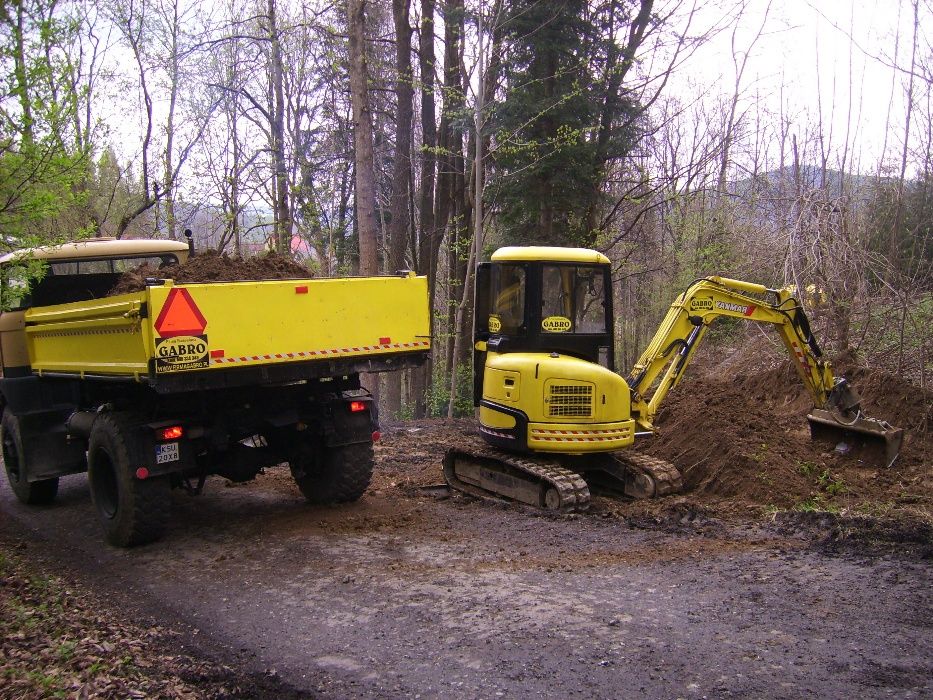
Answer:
[{"left": 0, "top": 0, "right": 933, "bottom": 417}]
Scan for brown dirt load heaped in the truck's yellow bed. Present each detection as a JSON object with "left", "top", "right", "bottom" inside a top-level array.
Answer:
[{"left": 108, "top": 250, "right": 311, "bottom": 296}]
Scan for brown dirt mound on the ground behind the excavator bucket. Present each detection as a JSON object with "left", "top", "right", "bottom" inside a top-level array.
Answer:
[{"left": 646, "top": 361, "right": 933, "bottom": 510}]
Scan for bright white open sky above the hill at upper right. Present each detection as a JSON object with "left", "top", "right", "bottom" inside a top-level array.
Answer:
[{"left": 670, "top": 0, "right": 930, "bottom": 172}]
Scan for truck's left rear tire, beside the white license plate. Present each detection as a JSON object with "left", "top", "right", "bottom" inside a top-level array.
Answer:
[{"left": 87, "top": 413, "right": 171, "bottom": 547}]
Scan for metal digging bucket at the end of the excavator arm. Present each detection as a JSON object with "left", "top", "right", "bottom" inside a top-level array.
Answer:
[{"left": 807, "top": 379, "right": 904, "bottom": 467}]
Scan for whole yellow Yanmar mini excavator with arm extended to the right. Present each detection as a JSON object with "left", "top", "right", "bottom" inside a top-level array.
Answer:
[{"left": 444, "top": 246, "right": 903, "bottom": 512}]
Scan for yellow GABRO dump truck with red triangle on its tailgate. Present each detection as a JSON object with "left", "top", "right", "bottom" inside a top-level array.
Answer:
[{"left": 0, "top": 239, "right": 430, "bottom": 546}]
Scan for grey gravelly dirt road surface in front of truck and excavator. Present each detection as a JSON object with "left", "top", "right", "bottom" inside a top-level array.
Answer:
[{"left": 0, "top": 422, "right": 933, "bottom": 698}]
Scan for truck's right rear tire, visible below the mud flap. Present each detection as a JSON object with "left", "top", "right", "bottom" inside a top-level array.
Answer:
[{"left": 292, "top": 442, "right": 373, "bottom": 503}]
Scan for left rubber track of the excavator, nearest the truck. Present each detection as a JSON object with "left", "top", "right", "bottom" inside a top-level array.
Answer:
[{"left": 444, "top": 440, "right": 590, "bottom": 513}]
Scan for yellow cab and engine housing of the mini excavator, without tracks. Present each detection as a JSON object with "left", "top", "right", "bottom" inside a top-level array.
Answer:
[{"left": 473, "top": 246, "right": 634, "bottom": 454}]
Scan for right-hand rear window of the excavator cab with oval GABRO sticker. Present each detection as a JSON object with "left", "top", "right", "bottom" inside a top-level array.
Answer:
[{"left": 541, "top": 265, "right": 606, "bottom": 334}]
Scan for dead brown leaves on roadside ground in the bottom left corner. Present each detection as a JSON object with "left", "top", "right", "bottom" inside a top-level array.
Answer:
[{"left": 0, "top": 541, "right": 243, "bottom": 700}]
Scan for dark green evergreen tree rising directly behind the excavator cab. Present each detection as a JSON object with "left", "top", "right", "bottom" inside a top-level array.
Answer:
[{"left": 489, "top": 0, "right": 632, "bottom": 245}]
